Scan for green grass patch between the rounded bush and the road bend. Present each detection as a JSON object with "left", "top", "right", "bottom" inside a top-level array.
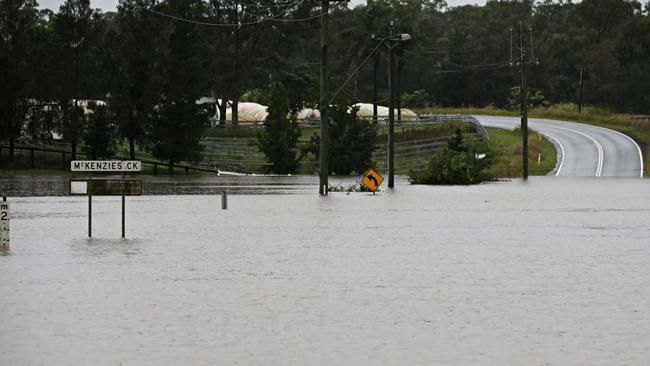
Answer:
[{"left": 487, "top": 128, "right": 557, "bottom": 178}]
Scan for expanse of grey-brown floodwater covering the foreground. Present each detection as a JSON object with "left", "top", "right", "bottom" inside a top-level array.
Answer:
[{"left": 0, "top": 177, "right": 650, "bottom": 365}]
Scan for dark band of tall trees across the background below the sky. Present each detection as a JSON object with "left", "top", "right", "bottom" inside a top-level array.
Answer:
[{"left": 0, "top": 0, "right": 650, "bottom": 163}]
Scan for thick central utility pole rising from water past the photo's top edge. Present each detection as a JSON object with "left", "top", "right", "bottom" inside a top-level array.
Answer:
[{"left": 318, "top": 0, "right": 329, "bottom": 196}]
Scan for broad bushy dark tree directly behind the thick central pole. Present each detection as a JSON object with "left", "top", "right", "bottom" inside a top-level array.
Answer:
[{"left": 308, "top": 105, "right": 377, "bottom": 175}]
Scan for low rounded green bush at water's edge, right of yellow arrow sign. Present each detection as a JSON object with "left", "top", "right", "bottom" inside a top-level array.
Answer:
[{"left": 409, "top": 130, "right": 494, "bottom": 184}]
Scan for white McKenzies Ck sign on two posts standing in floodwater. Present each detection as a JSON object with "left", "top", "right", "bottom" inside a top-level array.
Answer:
[{"left": 70, "top": 160, "right": 142, "bottom": 238}]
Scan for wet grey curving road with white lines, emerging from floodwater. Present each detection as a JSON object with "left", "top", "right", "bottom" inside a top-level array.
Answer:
[{"left": 474, "top": 116, "right": 643, "bottom": 178}]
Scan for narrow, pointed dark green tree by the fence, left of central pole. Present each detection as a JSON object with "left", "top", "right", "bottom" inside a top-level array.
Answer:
[{"left": 257, "top": 82, "right": 302, "bottom": 174}]
